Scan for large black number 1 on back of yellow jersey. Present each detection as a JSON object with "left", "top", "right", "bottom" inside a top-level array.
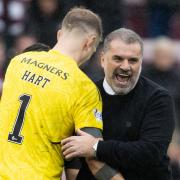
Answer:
[{"left": 8, "top": 94, "right": 31, "bottom": 144}]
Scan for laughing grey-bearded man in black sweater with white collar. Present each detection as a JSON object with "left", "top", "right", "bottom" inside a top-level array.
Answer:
[{"left": 62, "top": 28, "right": 174, "bottom": 180}]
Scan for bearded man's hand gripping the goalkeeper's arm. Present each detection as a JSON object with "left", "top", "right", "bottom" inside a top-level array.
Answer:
[{"left": 61, "top": 130, "right": 99, "bottom": 159}]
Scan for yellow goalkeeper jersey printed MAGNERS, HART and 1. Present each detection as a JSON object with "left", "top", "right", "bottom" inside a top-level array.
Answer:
[{"left": 0, "top": 50, "right": 102, "bottom": 180}]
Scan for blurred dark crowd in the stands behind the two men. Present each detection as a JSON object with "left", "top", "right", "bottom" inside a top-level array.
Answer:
[{"left": 0, "top": 0, "right": 180, "bottom": 180}]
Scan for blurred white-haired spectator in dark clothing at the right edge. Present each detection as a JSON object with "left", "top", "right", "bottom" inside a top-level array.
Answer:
[{"left": 143, "top": 37, "right": 180, "bottom": 178}]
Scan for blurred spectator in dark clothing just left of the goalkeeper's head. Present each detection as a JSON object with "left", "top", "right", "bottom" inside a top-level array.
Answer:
[{"left": 26, "top": 0, "right": 64, "bottom": 46}]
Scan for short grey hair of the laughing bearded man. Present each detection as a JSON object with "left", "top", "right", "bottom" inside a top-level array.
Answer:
[{"left": 103, "top": 28, "right": 143, "bottom": 55}]
